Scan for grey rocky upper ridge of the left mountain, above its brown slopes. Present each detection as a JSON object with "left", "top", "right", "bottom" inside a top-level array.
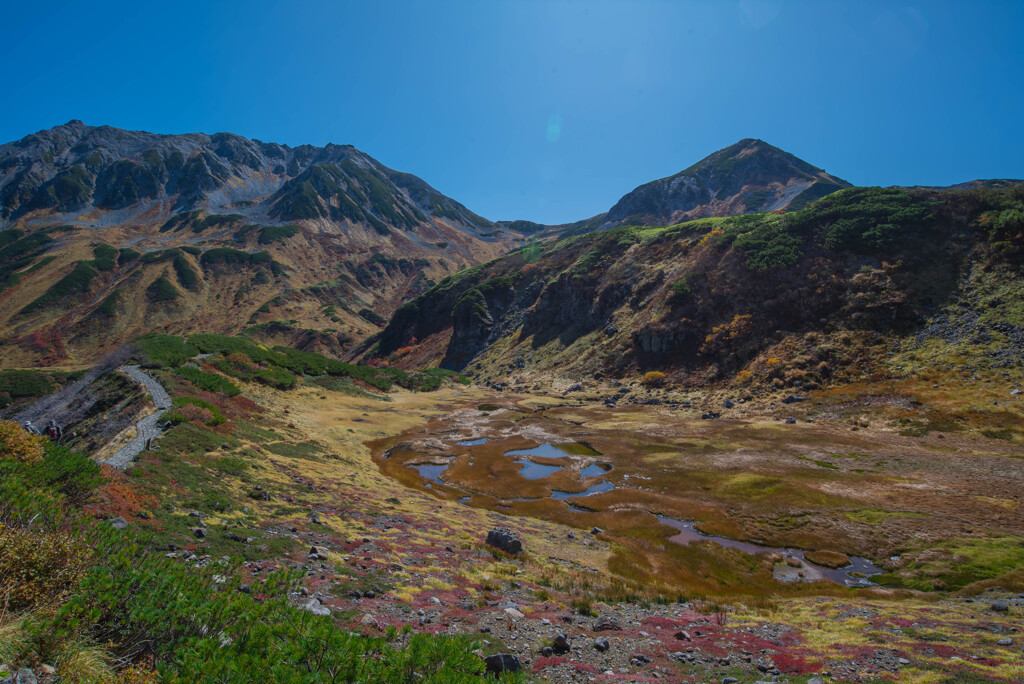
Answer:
[{"left": 0, "top": 121, "right": 492, "bottom": 234}]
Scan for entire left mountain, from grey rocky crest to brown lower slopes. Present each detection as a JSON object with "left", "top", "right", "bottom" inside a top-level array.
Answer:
[{"left": 0, "top": 121, "right": 520, "bottom": 365}]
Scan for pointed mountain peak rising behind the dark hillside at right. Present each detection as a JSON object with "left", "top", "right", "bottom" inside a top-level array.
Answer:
[{"left": 602, "top": 138, "right": 850, "bottom": 227}]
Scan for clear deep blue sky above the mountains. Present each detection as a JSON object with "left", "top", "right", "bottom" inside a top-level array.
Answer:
[{"left": 0, "top": 0, "right": 1024, "bottom": 222}]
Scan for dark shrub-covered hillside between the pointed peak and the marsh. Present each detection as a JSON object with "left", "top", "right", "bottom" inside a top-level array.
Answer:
[{"left": 378, "top": 185, "right": 1024, "bottom": 384}]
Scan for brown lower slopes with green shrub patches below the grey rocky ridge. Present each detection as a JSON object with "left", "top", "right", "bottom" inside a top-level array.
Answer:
[{"left": 0, "top": 210, "right": 516, "bottom": 366}]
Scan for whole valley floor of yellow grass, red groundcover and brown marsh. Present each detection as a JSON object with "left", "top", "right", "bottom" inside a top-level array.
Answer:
[{"left": 97, "top": 374, "right": 1024, "bottom": 683}]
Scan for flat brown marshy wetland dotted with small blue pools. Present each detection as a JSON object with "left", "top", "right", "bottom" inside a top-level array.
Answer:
[{"left": 376, "top": 397, "right": 1024, "bottom": 594}]
